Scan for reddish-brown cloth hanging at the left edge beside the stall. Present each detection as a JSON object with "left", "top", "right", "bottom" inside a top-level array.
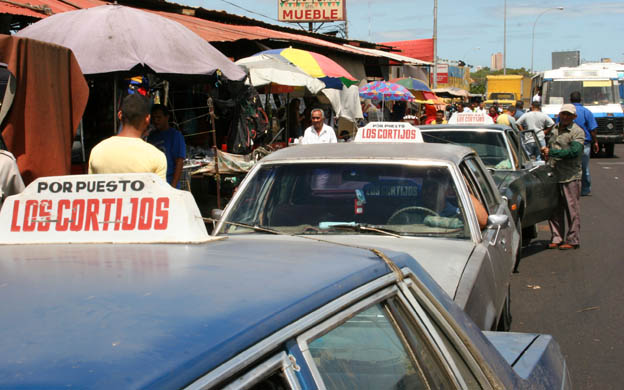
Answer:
[{"left": 0, "top": 35, "right": 89, "bottom": 183}]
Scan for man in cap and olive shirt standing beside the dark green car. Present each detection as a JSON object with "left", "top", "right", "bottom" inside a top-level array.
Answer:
[{"left": 542, "top": 104, "right": 585, "bottom": 249}]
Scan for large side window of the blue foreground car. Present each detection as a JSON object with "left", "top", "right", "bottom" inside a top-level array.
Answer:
[{"left": 308, "top": 299, "right": 454, "bottom": 390}]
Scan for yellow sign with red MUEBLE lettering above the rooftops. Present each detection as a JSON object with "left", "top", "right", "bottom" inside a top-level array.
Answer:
[{"left": 277, "top": 0, "right": 347, "bottom": 23}]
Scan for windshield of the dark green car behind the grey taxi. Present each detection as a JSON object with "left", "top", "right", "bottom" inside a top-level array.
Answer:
[{"left": 422, "top": 130, "right": 513, "bottom": 169}]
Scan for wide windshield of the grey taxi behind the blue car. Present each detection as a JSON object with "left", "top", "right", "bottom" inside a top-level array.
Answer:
[{"left": 221, "top": 163, "right": 469, "bottom": 238}]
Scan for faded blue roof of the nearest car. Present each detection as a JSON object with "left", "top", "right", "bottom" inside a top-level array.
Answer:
[{"left": 0, "top": 237, "right": 422, "bottom": 389}]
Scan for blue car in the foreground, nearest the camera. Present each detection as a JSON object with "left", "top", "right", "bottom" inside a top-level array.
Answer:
[{"left": 0, "top": 236, "right": 570, "bottom": 389}]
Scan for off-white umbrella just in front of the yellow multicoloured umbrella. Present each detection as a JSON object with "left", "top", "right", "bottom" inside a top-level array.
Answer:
[{"left": 236, "top": 54, "right": 325, "bottom": 94}]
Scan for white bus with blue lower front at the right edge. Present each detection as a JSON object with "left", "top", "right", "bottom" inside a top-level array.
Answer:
[{"left": 533, "top": 64, "right": 624, "bottom": 156}]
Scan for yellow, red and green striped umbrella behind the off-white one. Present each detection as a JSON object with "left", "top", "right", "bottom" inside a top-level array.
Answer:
[{"left": 255, "top": 47, "right": 356, "bottom": 89}]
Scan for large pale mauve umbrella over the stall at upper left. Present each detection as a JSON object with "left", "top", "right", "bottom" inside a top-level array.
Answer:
[{"left": 16, "top": 5, "right": 245, "bottom": 80}]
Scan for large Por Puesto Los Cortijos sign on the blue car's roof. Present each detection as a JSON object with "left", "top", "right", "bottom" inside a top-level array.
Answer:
[{"left": 0, "top": 173, "right": 210, "bottom": 244}]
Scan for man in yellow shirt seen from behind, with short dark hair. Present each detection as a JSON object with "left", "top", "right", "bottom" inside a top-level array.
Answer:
[{"left": 89, "top": 93, "right": 167, "bottom": 180}]
